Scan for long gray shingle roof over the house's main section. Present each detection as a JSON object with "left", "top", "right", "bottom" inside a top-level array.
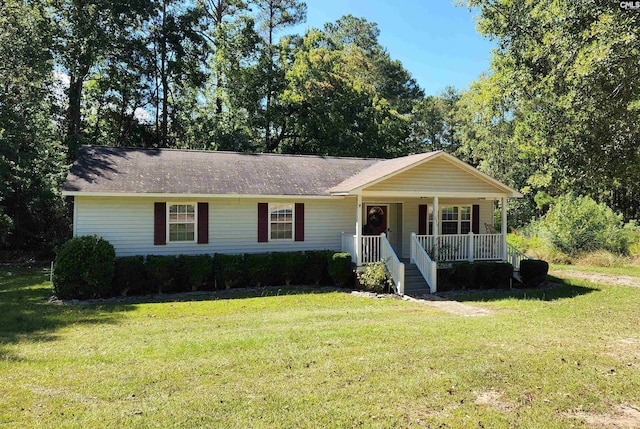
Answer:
[{"left": 62, "top": 146, "right": 380, "bottom": 196}]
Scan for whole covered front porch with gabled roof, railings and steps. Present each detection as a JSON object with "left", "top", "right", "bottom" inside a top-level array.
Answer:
[{"left": 331, "top": 152, "right": 522, "bottom": 294}]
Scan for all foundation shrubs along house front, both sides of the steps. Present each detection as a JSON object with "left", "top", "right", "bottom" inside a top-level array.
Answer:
[{"left": 53, "top": 236, "right": 549, "bottom": 299}]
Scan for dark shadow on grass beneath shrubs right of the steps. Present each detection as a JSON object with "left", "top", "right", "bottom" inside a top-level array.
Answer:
[{"left": 437, "top": 276, "right": 600, "bottom": 302}]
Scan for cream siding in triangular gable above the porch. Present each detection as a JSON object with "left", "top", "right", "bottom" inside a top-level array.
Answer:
[{"left": 364, "top": 158, "right": 504, "bottom": 195}]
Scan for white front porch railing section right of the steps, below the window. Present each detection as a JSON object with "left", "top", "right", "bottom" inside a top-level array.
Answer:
[{"left": 416, "top": 232, "right": 503, "bottom": 262}]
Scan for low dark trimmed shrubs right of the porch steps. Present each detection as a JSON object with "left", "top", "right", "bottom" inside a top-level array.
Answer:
[{"left": 438, "top": 259, "right": 549, "bottom": 291}]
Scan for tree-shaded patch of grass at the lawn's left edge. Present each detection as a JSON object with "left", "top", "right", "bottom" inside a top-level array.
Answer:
[{"left": 0, "top": 267, "right": 134, "bottom": 360}]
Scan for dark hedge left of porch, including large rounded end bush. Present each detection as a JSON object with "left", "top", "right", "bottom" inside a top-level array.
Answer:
[{"left": 53, "top": 236, "right": 354, "bottom": 299}]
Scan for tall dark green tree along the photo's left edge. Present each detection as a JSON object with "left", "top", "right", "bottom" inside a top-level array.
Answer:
[{"left": 0, "top": 0, "right": 67, "bottom": 251}]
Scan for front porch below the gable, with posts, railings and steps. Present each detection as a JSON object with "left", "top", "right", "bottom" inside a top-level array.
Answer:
[{"left": 341, "top": 196, "right": 524, "bottom": 294}]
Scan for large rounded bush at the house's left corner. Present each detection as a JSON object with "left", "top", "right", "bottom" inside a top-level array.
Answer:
[{"left": 53, "top": 235, "right": 116, "bottom": 299}]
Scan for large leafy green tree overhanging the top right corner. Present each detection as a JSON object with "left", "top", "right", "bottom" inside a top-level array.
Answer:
[{"left": 467, "top": 0, "right": 640, "bottom": 218}]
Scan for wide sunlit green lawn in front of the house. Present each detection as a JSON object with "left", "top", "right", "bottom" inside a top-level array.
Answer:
[{"left": 0, "top": 268, "right": 640, "bottom": 428}]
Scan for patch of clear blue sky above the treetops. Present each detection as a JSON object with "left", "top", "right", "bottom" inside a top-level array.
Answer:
[{"left": 287, "top": 0, "right": 494, "bottom": 94}]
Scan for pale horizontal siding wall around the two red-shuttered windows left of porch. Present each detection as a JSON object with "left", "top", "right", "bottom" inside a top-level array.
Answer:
[{"left": 74, "top": 196, "right": 356, "bottom": 256}]
